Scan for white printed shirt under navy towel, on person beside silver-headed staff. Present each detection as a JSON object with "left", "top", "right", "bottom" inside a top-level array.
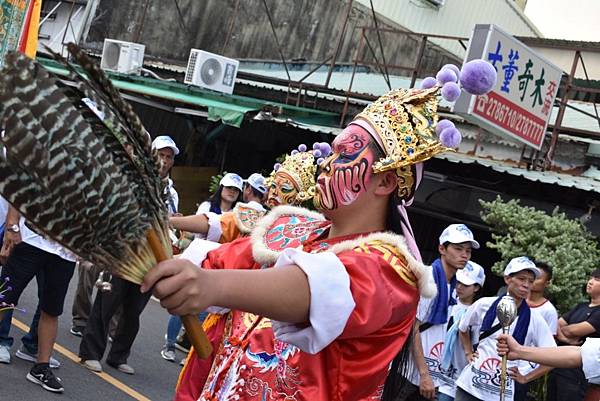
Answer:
[{"left": 456, "top": 297, "right": 556, "bottom": 401}]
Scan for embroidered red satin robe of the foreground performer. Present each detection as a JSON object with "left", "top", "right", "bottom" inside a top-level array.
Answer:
[{"left": 175, "top": 231, "right": 419, "bottom": 401}]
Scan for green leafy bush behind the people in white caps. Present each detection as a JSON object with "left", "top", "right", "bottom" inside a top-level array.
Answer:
[{"left": 480, "top": 197, "right": 600, "bottom": 313}]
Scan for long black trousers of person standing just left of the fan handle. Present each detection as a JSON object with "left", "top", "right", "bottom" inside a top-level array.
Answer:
[{"left": 79, "top": 277, "right": 151, "bottom": 367}]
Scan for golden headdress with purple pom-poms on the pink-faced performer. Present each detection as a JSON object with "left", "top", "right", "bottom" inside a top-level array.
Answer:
[{"left": 350, "top": 60, "right": 496, "bottom": 199}]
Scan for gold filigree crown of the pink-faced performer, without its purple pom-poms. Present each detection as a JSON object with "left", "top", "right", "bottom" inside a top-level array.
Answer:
[{"left": 355, "top": 86, "right": 452, "bottom": 199}]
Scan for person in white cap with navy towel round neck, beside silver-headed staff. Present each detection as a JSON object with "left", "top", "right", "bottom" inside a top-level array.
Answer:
[{"left": 454, "top": 256, "right": 556, "bottom": 401}]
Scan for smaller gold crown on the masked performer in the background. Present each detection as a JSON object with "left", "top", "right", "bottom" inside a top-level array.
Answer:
[{"left": 268, "top": 151, "right": 317, "bottom": 203}]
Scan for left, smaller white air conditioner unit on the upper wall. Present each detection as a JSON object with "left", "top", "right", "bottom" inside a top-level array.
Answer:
[{"left": 100, "top": 39, "right": 146, "bottom": 75}]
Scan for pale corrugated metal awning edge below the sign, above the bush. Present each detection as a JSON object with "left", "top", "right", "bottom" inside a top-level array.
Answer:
[{"left": 435, "top": 153, "right": 600, "bottom": 193}]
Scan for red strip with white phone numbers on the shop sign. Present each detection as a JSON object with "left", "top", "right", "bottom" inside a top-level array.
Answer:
[{"left": 473, "top": 92, "right": 545, "bottom": 144}]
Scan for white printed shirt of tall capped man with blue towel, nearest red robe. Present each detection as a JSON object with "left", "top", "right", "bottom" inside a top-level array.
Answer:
[{"left": 407, "top": 284, "right": 450, "bottom": 387}]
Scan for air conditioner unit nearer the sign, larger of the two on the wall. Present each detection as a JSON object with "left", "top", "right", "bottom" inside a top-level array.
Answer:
[{"left": 183, "top": 49, "right": 240, "bottom": 94}]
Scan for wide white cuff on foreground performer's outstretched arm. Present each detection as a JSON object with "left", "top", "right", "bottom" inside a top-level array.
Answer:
[{"left": 272, "top": 249, "right": 356, "bottom": 354}]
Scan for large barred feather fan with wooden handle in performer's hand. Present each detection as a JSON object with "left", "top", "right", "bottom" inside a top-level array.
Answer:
[{"left": 0, "top": 44, "right": 211, "bottom": 357}]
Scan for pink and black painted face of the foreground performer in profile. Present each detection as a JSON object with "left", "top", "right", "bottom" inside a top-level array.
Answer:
[{"left": 314, "top": 125, "right": 376, "bottom": 210}]
